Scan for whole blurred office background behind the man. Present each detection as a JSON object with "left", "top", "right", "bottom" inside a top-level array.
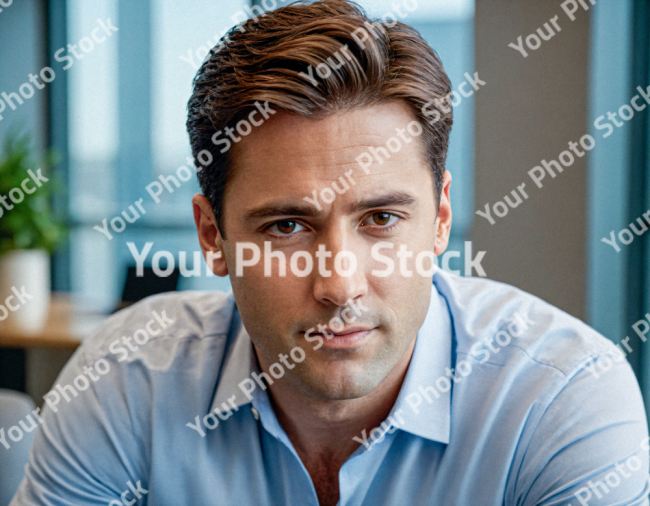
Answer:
[{"left": 0, "top": 0, "right": 650, "bottom": 498}]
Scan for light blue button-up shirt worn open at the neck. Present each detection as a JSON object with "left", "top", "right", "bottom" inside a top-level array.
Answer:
[{"left": 10, "top": 269, "right": 649, "bottom": 506}]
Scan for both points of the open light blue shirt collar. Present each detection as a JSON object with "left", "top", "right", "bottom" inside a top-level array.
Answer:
[{"left": 210, "top": 285, "right": 453, "bottom": 444}]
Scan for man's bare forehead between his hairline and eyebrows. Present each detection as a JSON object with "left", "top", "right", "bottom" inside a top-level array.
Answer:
[{"left": 225, "top": 108, "right": 432, "bottom": 204}]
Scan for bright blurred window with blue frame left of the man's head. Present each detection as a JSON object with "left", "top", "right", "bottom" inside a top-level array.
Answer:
[{"left": 67, "top": 0, "right": 244, "bottom": 309}]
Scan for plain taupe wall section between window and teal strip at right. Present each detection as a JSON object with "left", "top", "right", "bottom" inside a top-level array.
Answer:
[{"left": 473, "top": 0, "right": 589, "bottom": 318}]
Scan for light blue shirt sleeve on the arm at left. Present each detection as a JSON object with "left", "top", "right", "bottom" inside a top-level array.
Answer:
[{"left": 10, "top": 346, "right": 148, "bottom": 506}]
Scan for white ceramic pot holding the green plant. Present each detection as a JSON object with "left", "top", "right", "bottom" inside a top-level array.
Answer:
[{"left": 0, "top": 249, "right": 50, "bottom": 334}]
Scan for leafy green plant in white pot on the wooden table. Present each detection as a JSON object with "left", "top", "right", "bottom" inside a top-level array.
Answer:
[{"left": 0, "top": 133, "right": 64, "bottom": 333}]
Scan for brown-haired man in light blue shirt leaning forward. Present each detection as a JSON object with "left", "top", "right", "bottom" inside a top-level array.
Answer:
[{"left": 13, "top": 0, "right": 649, "bottom": 506}]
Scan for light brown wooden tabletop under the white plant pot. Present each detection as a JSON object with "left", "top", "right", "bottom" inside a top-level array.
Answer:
[{"left": 0, "top": 294, "right": 107, "bottom": 350}]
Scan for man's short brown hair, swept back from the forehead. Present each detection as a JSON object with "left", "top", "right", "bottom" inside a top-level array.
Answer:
[{"left": 187, "top": 0, "right": 452, "bottom": 237}]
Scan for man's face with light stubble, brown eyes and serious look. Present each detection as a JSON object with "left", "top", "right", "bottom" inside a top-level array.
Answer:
[{"left": 192, "top": 102, "right": 451, "bottom": 399}]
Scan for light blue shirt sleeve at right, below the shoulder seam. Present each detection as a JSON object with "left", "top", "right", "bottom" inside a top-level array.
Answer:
[{"left": 509, "top": 354, "right": 650, "bottom": 506}]
